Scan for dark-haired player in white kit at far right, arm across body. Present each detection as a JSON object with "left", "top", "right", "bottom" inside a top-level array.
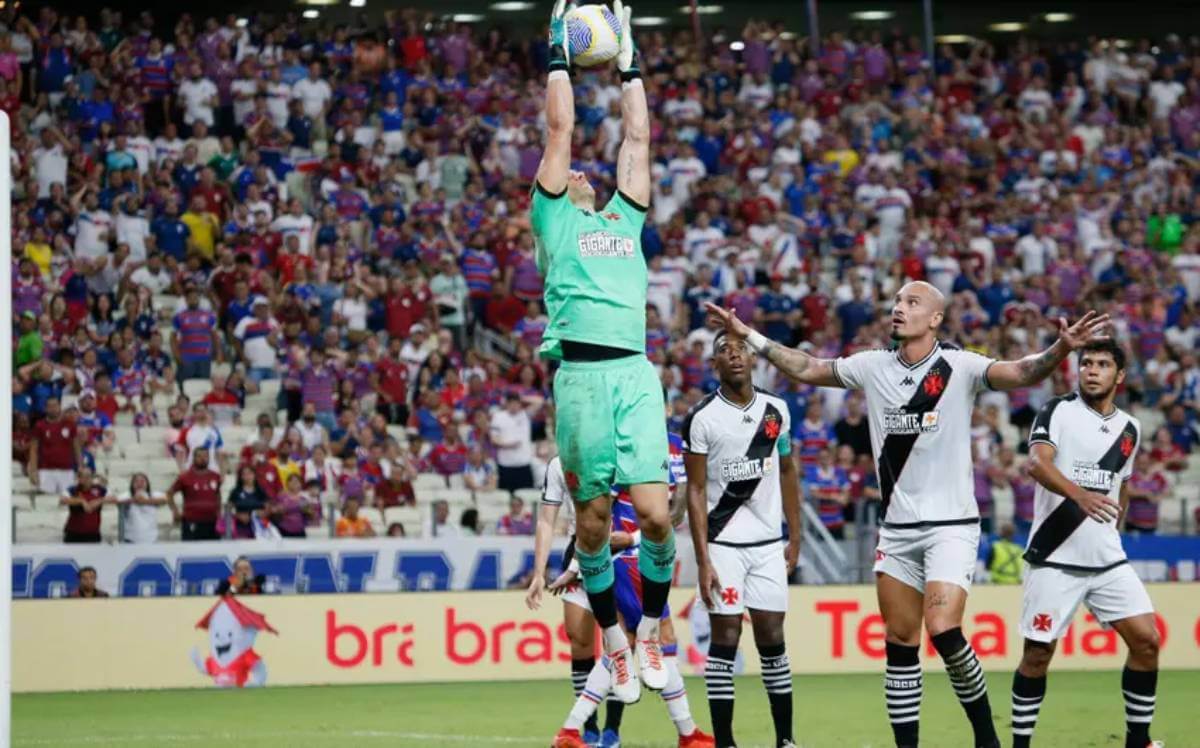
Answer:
[{"left": 1013, "top": 340, "right": 1160, "bottom": 748}]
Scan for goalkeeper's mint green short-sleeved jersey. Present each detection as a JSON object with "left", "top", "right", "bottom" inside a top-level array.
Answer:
[{"left": 530, "top": 185, "right": 647, "bottom": 359}]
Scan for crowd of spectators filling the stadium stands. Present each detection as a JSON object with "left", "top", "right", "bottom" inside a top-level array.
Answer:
[{"left": 7, "top": 6, "right": 1200, "bottom": 541}]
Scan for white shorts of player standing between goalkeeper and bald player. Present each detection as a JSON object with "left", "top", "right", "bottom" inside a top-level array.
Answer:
[{"left": 708, "top": 541, "right": 787, "bottom": 616}]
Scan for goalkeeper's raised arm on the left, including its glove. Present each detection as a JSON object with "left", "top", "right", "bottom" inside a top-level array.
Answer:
[{"left": 538, "top": 0, "right": 575, "bottom": 195}]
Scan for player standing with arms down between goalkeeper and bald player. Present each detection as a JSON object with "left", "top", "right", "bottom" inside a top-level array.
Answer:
[{"left": 683, "top": 334, "right": 800, "bottom": 748}]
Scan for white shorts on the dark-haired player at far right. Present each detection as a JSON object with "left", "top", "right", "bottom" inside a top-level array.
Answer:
[{"left": 1021, "top": 563, "right": 1154, "bottom": 642}]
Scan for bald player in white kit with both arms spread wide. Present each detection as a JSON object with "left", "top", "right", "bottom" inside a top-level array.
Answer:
[{"left": 707, "top": 281, "right": 1109, "bottom": 748}]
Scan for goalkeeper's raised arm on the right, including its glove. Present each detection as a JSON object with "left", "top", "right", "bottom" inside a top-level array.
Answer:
[{"left": 612, "top": 0, "right": 650, "bottom": 208}]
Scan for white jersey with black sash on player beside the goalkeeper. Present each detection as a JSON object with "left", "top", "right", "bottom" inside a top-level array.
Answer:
[{"left": 683, "top": 388, "right": 792, "bottom": 546}]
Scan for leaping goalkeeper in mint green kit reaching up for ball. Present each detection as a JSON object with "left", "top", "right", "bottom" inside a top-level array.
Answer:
[{"left": 530, "top": 0, "right": 676, "bottom": 704}]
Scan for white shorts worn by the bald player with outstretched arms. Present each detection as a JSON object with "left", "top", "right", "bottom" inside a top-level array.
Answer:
[{"left": 875, "top": 522, "right": 979, "bottom": 594}]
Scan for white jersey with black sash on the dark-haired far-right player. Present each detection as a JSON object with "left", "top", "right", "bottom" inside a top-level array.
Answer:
[{"left": 1025, "top": 393, "right": 1141, "bottom": 572}]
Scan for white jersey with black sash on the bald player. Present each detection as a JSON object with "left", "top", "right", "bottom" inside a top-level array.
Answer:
[{"left": 833, "top": 343, "right": 995, "bottom": 528}]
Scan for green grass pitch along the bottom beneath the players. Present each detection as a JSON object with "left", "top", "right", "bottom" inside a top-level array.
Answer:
[{"left": 13, "top": 671, "right": 1200, "bottom": 748}]
